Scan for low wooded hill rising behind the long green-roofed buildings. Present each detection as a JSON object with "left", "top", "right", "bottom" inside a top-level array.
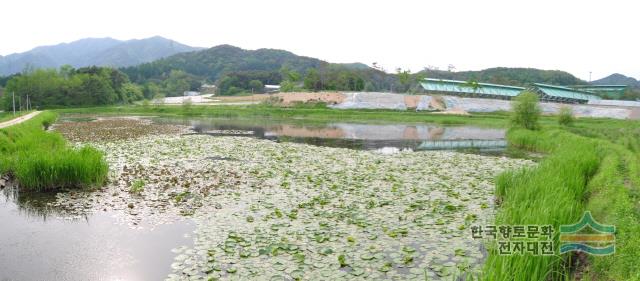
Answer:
[{"left": 420, "top": 67, "right": 587, "bottom": 86}]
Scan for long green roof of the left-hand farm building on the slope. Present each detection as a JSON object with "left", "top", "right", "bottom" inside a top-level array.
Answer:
[{"left": 420, "top": 78, "right": 525, "bottom": 97}]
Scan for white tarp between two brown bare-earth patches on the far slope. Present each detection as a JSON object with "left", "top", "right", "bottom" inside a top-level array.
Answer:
[{"left": 330, "top": 93, "right": 407, "bottom": 110}]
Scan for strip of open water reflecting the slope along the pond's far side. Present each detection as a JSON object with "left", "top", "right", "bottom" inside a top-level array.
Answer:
[{"left": 153, "top": 117, "right": 506, "bottom": 152}]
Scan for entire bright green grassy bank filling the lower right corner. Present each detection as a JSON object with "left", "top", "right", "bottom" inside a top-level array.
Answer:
[{"left": 483, "top": 119, "right": 640, "bottom": 280}]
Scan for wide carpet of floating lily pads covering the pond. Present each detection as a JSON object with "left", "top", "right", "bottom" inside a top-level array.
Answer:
[{"left": 53, "top": 116, "right": 533, "bottom": 280}]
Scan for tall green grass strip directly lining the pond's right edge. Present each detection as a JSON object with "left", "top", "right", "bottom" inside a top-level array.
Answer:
[{"left": 484, "top": 129, "right": 600, "bottom": 280}]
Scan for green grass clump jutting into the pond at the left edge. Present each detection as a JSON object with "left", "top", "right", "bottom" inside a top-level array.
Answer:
[{"left": 0, "top": 111, "right": 108, "bottom": 191}]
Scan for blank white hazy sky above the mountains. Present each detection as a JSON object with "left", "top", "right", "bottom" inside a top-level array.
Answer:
[{"left": 0, "top": 0, "right": 640, "bottom": 80}]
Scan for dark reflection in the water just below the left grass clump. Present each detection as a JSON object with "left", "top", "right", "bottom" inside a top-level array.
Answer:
[{"left": 2, "top": 182, "right": 88, "bottom": 221}]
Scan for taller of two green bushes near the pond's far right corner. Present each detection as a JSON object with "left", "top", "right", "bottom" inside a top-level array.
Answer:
[{"left": 511, "top": 91, "right": 541, "bottom": 130}]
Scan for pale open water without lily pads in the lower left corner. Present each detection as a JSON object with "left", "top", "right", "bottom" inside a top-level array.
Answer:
[{"left": 0, "top": 179, "right": 194, "bottom": 280}]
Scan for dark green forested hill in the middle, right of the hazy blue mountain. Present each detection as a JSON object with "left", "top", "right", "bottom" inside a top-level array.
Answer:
[{"left": 122, "top": 45, "right": 327, "bottom": 82}]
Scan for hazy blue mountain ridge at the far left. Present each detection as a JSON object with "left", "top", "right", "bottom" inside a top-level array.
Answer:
[{"left": 0, "top": 36, "right": 200, "bottom": 76}]
